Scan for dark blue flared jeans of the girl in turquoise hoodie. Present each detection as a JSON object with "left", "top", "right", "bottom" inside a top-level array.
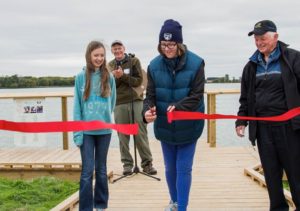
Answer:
[{"left": 79, "top": 134, "right": 111, "bottom": 211}]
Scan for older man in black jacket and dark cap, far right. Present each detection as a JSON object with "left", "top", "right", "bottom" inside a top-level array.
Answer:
[{"left": 236, "top": 20, "right": 300, "bottom": 211}]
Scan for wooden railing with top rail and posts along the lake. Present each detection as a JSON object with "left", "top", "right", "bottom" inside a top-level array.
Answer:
[{"left": 0, "top": 90, "right": 240, "bottom": 150}]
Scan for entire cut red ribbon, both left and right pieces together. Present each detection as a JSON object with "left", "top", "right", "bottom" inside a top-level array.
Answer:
[{"left": 0, "top": 107, "right": 300, "bottom": 135}]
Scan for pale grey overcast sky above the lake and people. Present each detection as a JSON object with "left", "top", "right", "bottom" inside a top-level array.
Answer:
[{"left": 0, "top": 0, "right": 300, "bottom": 78}]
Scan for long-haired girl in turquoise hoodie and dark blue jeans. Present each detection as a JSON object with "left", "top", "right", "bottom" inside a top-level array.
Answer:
[{"left": 74, "top": 41, "right": 116, "bottom": 211}]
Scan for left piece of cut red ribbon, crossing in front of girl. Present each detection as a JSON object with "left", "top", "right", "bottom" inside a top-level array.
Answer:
[{"left": 0, "top": 120, "right": 138, "bottom": 135}]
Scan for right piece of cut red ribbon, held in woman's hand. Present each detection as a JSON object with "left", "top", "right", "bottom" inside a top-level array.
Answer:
[{"left": 167, "top": 107, "right": 300, "bottom": 123}]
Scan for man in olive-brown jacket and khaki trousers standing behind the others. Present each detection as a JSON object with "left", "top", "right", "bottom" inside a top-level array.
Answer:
[{"left": 108, "top": 40, "right": 157, "bottom": 175}]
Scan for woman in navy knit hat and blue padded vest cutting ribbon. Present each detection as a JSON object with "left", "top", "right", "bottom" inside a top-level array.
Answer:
[{"left": 143, "top": 19, "right": 205, "bottom": 211}]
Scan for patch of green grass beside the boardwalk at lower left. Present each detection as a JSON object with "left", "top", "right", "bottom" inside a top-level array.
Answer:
[{"left": 0, "top": 177, "right": 79, "bottom": 211}]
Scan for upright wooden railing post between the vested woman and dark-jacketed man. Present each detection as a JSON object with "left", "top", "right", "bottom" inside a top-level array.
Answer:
[{"left": 207, "top": 93, "right": 216, "bottom": 147}]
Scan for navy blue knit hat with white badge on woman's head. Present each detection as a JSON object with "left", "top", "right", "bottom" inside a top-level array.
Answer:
[{"left": 159, "top": 19, "right": 182, "bottom": 43}]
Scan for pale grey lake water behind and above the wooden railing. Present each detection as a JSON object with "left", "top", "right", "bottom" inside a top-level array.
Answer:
[{"left": 0, "top": 83, "right": 249, "bottom": 148}]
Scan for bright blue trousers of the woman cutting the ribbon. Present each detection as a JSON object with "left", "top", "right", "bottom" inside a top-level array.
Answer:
[{"left": 161, "top": 140, "right": 197, "bottom": 211}]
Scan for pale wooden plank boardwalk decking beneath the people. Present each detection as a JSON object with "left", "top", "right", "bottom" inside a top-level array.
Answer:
[{"left": 0, "top": 140, "right": 269, "bottom": 211}]
